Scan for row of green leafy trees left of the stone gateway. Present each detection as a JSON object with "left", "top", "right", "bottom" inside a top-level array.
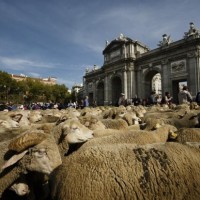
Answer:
[{"left": 0, "top": 71, "right": 71, "bottom": 103}]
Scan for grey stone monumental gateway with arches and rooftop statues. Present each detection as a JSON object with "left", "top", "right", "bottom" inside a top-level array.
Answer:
[{"left": 83, "top": 23, "right": 200, "bottom": 105}]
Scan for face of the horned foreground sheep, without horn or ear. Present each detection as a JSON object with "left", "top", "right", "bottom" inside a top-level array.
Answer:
[{"left": 26, "top": 138, "right": 62, "bottom": 174}]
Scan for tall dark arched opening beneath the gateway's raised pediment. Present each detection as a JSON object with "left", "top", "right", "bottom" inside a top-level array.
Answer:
[{"left": 111, "top": 76, "right": 122, "bottom": 106}]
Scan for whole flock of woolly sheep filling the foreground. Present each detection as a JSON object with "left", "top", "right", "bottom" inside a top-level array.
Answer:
[{"left": 0, "top": 103, "right": 200, "bottom": 200}]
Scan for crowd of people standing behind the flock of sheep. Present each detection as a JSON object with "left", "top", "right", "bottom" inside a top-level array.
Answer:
[{"left": 0, "top": 86, "right": 200, "bottom": 111}]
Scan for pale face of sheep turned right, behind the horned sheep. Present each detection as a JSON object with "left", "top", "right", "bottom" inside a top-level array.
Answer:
[{"left": 63, "top": 120, "right": 93, "bottom": 144}]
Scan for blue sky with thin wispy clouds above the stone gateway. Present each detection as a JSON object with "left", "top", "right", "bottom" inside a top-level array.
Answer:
[{"left": 0, "top": 0, "right": 200, "bottom": 89}]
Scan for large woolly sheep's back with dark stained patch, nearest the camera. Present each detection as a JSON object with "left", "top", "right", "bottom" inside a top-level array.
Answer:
[{"left": 50, "top": 142, "right": 200, "bottom": 200}]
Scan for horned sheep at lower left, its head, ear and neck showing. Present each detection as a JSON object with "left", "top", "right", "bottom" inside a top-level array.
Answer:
[{"left": 0, "top": 130, "right": 62, "bottom": 197}]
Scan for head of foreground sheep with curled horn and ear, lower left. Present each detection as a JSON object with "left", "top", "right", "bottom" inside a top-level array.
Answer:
[{"left": 2, "top": 130, "right": 62, "bottom": 174}]
